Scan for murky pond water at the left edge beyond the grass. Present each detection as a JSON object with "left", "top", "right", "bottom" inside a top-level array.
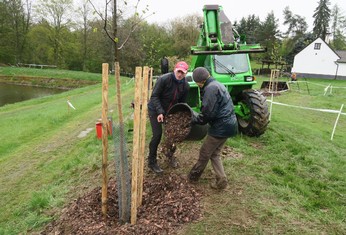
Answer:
[{"left": 0, "top": 83, "right": 65, "bottom": 107}]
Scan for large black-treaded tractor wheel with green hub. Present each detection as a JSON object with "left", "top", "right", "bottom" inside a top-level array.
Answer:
[{"left": 237, "top": 89, "right": 269, "bottom": 137}]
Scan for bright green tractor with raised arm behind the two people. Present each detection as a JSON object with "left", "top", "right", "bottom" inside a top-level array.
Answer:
[{"left": 186, "top": 5, "right": 269, "bottom": 136}]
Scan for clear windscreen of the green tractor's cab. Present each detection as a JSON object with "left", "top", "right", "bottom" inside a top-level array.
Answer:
[{"left": 214, "top": 54, "right": 249, "bottom": 74}]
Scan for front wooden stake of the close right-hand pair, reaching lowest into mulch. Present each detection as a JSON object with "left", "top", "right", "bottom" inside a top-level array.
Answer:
[{"left": 131, "top": 67, "right": 142, "bottom": 224}]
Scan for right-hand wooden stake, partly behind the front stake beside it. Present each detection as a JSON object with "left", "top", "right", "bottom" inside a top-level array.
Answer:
[{"left": 137, "top": 67, "right": 149, "bottom": 206}]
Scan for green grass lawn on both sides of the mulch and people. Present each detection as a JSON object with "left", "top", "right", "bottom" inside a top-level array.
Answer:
[{"left": 0, "top": 68, "right": 346, "bottom": 234}]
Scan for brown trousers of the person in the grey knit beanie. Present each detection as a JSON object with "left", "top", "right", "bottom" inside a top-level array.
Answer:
[{"left": 190, "top": 135, "right": 227, "bottom": 180}]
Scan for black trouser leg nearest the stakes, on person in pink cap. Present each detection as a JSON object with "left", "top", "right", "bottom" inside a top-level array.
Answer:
[{"left": 148, "top": 113, "right": 162, "bottom": 165}]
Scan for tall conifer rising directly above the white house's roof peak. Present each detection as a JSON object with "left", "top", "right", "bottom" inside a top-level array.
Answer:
[{"left": 313, "top": 0, "right": 331, "bottom": 40}]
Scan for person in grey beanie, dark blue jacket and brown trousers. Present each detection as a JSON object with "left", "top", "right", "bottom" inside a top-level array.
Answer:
[{"left": 188, "top": 67, "right": 238, "bottom": 189}]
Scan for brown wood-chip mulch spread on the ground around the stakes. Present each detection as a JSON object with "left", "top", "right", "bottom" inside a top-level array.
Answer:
[{"left": 41, "top": 173, "right": 202, "bottom": 235}]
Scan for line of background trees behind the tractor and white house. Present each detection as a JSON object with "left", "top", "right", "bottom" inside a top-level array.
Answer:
[{"left": 0, "top": 0, "right": 346, "bottom": 73}]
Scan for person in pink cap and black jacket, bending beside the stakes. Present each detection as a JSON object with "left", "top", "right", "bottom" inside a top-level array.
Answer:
[{"left": 148, "top": 61, "right": 190, "bottom": 174}]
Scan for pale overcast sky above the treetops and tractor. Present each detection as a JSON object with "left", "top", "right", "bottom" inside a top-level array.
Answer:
[{"left": 130, "top": 0, "right": 346, "bottom": 30}]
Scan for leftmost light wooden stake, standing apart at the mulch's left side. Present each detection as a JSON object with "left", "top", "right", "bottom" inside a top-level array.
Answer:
[{"left": 101, "top": 63, "right": 109, "bottom": 218}]
